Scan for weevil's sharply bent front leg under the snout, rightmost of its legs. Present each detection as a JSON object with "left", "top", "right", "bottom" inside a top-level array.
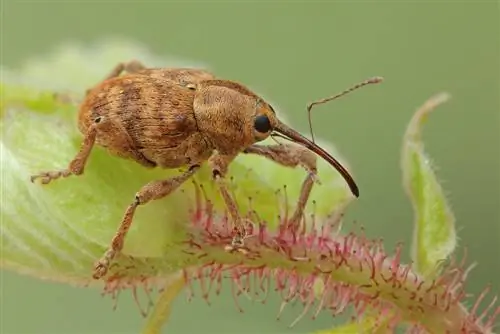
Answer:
[{"left": 243, "top": 144, "right": 318, "bottom": 228}]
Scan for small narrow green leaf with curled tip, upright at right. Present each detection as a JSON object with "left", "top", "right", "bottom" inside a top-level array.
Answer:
[{"left": 402, "top": 93, "right": 456, "bottom": 277}]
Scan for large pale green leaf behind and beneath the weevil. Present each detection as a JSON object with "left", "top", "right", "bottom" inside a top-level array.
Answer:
[{"left": 0, "top": 41, "right": 352, "bottom": 282}]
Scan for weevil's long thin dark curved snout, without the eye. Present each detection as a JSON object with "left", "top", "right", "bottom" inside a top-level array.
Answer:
[{"left": 274, "top": 121, "right": 359, "bottom": 197}]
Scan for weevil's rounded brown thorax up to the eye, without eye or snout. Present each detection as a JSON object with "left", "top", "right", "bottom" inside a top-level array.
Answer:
[{"left": 193, "top": 80, "right": 274, "bottom": 154}]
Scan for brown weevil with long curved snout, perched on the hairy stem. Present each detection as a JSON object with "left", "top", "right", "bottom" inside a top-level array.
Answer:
[{"left": 31, "top": 61, "right": 378, "bottom": 279}]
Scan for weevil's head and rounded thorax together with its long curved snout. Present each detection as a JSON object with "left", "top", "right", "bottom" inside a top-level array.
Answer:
[{"left": 194, "top": 80, "right": 359, "bottom": 197}]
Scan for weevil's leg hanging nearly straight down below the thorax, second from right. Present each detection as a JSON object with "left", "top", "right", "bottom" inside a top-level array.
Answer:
[{"left": 208, "top": 152, "right": 246, "bottom": 248}]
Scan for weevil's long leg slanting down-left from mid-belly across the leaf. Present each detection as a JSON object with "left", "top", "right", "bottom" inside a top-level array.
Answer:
[{"left": 93, "top": 165, "right": 199, "bottom": 279}]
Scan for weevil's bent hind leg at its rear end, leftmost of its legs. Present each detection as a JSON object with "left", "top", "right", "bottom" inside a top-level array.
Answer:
[{"left": 31, "top": 116, "right": 104, "bottom": 184}]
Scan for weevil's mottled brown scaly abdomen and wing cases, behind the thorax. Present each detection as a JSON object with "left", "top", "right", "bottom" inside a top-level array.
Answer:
[{"left": 78, "top": 74, "right": 212, "bottom": 168}]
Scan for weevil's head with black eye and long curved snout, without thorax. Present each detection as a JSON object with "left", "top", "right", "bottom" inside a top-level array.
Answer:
[{"left": 253, "top": 101, "right": 359, "bottom": 197}]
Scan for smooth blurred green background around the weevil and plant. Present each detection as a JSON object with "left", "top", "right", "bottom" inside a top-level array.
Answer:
[{"left": 0, "top": 0, "right": 500, "bottom": 334}]
